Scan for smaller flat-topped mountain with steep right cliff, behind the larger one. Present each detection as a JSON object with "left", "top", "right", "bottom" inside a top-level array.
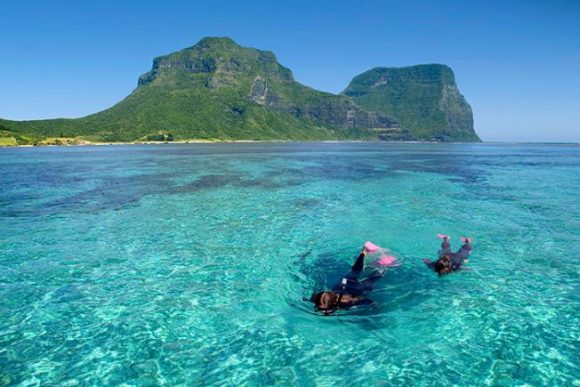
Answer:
[{"left": 343, "top": 64, "right": 480, "bottom": 141}]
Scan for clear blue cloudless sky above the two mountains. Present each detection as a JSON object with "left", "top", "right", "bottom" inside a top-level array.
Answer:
[{"left": 0, "top": 0, "right": 580, "bottom": 142}]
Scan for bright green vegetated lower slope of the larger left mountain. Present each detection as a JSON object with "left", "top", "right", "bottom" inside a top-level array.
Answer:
[{"left": 1, "top": 74, "right": 344, "bottom": 141}]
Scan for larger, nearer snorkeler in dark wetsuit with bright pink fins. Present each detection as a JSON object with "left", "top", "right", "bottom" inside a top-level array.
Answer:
[{"left": 311, "top": 242, "right": 399, "bottom": 315}]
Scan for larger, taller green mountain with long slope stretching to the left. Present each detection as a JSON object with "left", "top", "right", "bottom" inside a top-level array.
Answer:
[{"left": 0, "top": 38, "right": 399, "bottom": 141}]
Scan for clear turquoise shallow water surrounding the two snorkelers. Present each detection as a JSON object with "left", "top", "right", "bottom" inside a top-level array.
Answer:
[{"left": 0, "top": 144, "right": 580, "bottom": 385}]
